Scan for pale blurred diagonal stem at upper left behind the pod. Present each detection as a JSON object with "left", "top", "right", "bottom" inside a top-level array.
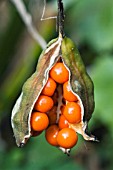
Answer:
[{"left": 10, "top": 0, "right": 46, "bottom": 49}]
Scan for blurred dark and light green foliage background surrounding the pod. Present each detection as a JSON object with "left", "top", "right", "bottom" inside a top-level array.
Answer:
[{"left": 0, "top": 0, "right": 113, "bottom": 170}]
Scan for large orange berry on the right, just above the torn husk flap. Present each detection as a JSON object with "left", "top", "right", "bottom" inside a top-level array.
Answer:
[{"left": 63, "top": 102, "right": 81, "bottom": 123}]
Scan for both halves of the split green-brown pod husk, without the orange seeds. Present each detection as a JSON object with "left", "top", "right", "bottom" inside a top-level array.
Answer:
[{"left": 11, "top": 36, "right": 96, "bottom": 153}]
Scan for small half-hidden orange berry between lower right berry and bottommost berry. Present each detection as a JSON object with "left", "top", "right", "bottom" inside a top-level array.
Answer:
[{"left": 58, "top": 115, "right": 69, "bottom": 129}]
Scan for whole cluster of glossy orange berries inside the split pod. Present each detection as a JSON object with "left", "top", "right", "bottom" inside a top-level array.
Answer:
[{"left": 31, "top": 62, "right": 81, "bottom": 149}]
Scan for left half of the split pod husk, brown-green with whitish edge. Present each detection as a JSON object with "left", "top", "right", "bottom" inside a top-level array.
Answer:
[{"left": 11, "top": 37, "right": 62, "bottom": 147}]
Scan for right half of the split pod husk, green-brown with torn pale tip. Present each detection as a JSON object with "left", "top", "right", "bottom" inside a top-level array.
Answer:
[{"left": 61, "top": 37, "right": 96, "bottom": 141}]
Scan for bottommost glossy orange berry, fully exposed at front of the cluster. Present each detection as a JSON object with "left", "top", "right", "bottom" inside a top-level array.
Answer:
[{"left": 57, "top": 128, "right": 78, "bottom": 149}]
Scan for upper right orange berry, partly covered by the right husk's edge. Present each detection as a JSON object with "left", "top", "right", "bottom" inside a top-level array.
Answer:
[{"left": 63, "top": 81, "right": 78, "bottom": 102}]
